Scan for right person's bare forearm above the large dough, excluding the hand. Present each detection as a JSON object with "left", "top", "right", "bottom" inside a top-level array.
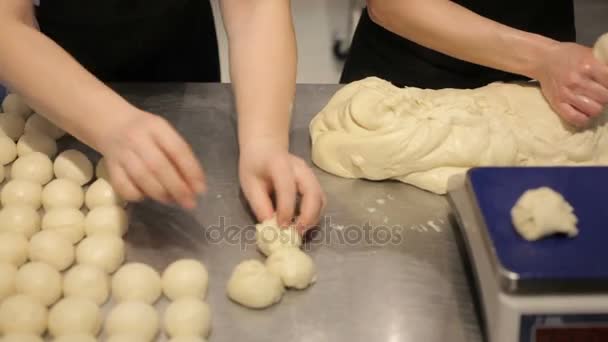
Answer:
[{"left": 368, "top": 0, "right": 557, "bottom": 78}]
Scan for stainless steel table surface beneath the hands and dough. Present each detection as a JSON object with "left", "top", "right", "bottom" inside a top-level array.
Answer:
[{"left": 63, "top": 84, "right": 481, "bottom": 342}]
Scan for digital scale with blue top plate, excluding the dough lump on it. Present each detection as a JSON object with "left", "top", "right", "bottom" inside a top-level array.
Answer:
[{"left": 448, "top": 167, "right": 608, "bottom": 342}]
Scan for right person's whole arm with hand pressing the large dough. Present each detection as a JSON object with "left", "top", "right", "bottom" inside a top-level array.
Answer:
[{"left": 368, "top": 0, "right": 608, "bottom": 124}]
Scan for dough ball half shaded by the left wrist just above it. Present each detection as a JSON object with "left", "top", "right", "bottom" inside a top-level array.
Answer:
[{"left": 53, "top": 150, "right": 93, "bottom": 185}]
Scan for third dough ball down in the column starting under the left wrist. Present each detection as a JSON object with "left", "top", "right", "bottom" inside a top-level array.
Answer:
[{"left": 42, "top": 208, "right": 84, "bottom": 244}]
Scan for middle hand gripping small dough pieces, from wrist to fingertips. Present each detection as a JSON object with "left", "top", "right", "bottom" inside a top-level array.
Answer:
[{"left": 239, "top": 143, "right": 325, "bottom": 233}]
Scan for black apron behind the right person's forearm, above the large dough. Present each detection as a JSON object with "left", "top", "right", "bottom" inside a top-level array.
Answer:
[{"left": 340, "top": 0, "right": 576, "bottom": 89}]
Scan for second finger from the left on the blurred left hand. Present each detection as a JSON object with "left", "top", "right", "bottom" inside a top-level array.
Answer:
[{"left": 122, "top": 151, "right": 170, "bottom": 204}]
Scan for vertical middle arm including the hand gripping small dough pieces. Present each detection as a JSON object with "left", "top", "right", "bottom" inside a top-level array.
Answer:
[{"left": 222, "top": 0, "right": 322, "bottom": 229}]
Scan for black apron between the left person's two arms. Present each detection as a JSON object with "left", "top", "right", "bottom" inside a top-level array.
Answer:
[{"left": 36, "top": 0, "right": 220, "bottom": 82}]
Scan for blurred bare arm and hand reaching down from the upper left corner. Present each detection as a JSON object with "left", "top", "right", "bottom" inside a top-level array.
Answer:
[{"left": 0, "top": 0, "right": 203, "bottom": 206}]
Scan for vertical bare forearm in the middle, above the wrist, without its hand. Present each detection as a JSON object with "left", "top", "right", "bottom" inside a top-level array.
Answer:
[{"left": 224, "top": 0, "right": 296, "bottom": 149}]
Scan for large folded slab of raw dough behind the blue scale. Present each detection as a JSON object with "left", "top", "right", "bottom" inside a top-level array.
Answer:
[{"left": 310, "top": 78, "right": 608, "bottom": 194}]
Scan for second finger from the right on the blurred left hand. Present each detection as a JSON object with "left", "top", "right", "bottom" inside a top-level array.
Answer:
[{"left": 137, "top": 136, "right": 196, "bottom": 209}]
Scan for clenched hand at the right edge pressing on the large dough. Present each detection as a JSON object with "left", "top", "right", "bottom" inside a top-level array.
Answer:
[{"left": 533, "top": 43, "right": 608, "bottom": 127}]
